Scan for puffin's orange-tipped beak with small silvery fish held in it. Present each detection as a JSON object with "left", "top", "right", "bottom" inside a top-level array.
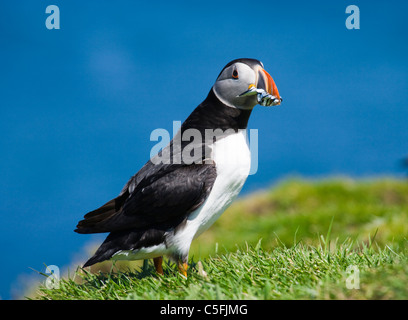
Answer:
[{"left": 240, "top": 66, "right": 282, "bottom": 106}]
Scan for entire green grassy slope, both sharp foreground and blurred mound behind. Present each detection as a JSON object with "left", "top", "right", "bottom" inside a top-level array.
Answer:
[{"left": 30, "top": 178, "right": 408, "bottom": 299}]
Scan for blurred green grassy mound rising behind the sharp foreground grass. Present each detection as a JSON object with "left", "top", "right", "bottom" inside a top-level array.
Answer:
[{"left": 192, "top": 178, "right": 408, "bottom": 257}]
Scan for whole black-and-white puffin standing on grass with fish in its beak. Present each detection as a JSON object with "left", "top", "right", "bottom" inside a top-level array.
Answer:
[{"left": 74, "top": 58, "right": 282, "bottom": 277}]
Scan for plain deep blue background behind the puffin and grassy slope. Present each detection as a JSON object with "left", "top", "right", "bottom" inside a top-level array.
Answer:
[{"left": 0, "top": 0, "right": 408, "bottom": 299}]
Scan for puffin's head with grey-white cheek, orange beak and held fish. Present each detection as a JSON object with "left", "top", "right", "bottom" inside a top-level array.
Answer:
[{"left": 213, "top": 59, "right": 282, "bottom": 110}]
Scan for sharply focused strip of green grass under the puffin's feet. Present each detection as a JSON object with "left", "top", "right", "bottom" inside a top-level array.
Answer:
[{"left": 32, "top": 242, "right": 408, "bottom": 300}]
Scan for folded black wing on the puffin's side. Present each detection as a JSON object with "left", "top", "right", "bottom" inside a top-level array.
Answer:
[{"left": 75, "top": 162, "right": 216, "bottom": 233}]
